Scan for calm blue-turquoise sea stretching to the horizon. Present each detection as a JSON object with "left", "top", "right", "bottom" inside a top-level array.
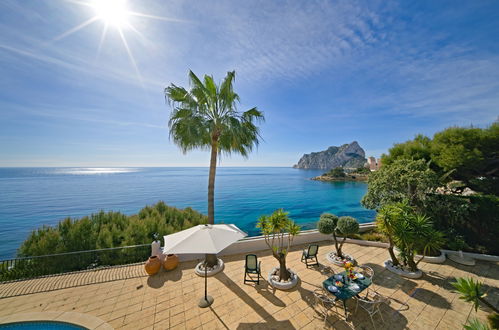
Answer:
[{"left": 0, "top": 167, "right": 375, "bottom": 260}]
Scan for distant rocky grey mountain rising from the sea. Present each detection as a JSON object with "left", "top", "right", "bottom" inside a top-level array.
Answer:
[{"left": 293, "top": 141, "right": 367, "bottom": 170}]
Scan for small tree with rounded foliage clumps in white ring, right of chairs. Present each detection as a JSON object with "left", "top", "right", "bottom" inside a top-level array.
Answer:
[{"left": 317, "top": 213, "right": 359, "bottom": 266}]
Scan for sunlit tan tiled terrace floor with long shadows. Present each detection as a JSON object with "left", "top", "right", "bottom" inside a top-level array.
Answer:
[{"left": 0, "top": 242, "right": 499, "bottom": 329}]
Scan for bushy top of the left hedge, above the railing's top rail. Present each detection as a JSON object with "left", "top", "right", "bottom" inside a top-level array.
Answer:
[{"left": 18, "top": 201, "right": 207, "bottom": 256}]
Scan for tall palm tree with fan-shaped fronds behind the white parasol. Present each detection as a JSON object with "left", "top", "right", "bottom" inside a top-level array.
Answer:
[{"left": 165, "top": 71, "right": 265, "bottom": 266}]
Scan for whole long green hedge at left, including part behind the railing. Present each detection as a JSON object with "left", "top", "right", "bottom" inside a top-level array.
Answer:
[{"left": 0, "top": 202, "right": 207, "bottom": 281}]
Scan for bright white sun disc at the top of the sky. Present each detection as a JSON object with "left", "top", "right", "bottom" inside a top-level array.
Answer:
[{"left": 91, "top": 0, "right": 130, "bottom": 28}]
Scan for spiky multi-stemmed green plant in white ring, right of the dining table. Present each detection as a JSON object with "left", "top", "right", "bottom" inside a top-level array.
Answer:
[{"left": 377, "top": 202, "right": 443, "bottom": 278}]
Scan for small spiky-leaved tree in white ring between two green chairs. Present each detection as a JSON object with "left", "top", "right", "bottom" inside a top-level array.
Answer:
[{"left": 256, "top": 209, "right": 300, "bottom": 290}]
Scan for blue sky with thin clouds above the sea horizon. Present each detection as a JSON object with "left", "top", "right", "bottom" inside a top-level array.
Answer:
[{"left": 0, "top": 0, "right": 499, "bottom": 166}]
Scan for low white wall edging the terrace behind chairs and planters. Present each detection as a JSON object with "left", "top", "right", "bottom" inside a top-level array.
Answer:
[{"left": 166, "top": 223, "right": 376, "bottom": 261}]
